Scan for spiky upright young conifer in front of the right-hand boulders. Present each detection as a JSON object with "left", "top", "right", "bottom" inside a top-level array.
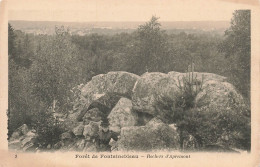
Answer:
[{"left": 173, "top": 71, "right": 204, "bottom": 148}]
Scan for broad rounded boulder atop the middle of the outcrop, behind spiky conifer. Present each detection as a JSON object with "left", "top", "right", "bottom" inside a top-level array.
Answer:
[{"left": 132, "top": 71, "right": 226, "bottom": 117}]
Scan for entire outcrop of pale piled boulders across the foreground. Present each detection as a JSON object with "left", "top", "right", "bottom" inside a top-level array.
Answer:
[{"left": 9, "top": 72, "right": 250, "bottom": 152}]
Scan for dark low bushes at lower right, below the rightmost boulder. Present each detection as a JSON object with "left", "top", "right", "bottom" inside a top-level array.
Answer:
[{"left": 176, "top": 108, "right": 250, "bottom": 150}]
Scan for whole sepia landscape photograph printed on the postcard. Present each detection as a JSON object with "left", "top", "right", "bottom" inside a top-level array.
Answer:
[{"left": 0, "top": 0, "right": 259, "bottom": 166}]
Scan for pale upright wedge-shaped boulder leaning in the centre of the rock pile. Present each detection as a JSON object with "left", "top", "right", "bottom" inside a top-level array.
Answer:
[{"left": 108, "top": 98, "right": 137, "bottom": 133}]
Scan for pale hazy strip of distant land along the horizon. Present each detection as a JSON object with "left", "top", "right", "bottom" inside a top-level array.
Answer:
[{"left": 9, "top": 20, "right": 230, "bottom": 35}]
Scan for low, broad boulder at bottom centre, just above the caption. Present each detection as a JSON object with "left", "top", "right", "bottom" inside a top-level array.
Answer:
[{"left": 118, "top": 118, "right": 179, "bottom": 151}]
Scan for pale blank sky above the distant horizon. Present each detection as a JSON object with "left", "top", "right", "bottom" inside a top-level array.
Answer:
[{"left": 8, "top": 0, "right": 254, "bottom": 22}]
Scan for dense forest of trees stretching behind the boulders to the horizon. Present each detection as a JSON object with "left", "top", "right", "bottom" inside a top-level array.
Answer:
[{"left": 8, "top": 10, "right": 251, "bottom": 150}]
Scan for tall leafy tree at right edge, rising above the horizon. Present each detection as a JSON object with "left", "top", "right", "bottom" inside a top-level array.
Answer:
[{"left": 219, "top": 10, "right": 251, "bottom": 98}]
